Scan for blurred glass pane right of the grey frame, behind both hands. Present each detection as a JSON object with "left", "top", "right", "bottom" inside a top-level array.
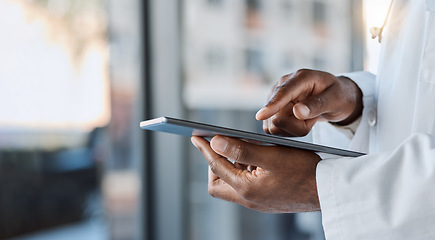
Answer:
[{"left": 181, "top": 0, "right": 362, "bottom": 240}]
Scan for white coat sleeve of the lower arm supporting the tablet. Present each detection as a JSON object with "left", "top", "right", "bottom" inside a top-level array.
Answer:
[{"left": 317, "top": 134, "right": 435, "bottom": 240}]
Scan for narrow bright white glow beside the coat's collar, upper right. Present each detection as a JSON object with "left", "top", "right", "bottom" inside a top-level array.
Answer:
[{"left": 363, "top": 0, "right": 390, "bottom": 73}]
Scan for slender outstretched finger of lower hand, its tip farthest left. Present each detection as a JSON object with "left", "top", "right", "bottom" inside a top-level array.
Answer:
[{"left": 191, "top": 137, "right": 249, "bottom": 187}]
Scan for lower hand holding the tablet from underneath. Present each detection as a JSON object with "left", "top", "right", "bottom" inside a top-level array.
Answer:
[{"left": 192, "top": 136, "right": 320, "bottom": 213}]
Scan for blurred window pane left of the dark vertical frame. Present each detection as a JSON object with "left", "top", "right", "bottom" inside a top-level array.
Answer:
[{"left": 0, "top": 0, "right": 142, "bottom": 240}]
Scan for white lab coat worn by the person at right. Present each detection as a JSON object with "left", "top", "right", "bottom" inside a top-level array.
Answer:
[{"left": 314, "top": 0, "right": 435, "bottom": 240}]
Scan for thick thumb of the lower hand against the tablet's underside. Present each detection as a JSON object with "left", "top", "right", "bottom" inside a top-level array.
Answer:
[{"left": 210, "top": 136, "right": 272, "bottom": 169}]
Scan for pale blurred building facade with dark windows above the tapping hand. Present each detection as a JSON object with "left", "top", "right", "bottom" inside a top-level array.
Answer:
[{"left": 182, "top": 0, "right": 354, "bottom": 110}]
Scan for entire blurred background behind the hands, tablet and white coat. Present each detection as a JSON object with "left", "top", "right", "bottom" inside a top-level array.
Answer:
[{"left": 0, "top": 0, "right": 388, "bottom": 240}]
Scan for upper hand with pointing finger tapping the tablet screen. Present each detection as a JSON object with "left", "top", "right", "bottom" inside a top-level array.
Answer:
[{"left": 256, "top": 69, "right": 363, "bottom": 137}]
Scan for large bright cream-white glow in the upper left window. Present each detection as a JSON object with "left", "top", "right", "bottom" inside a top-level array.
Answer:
[{"left": 0, "top": 0, "right": 110, "bottom": 131}]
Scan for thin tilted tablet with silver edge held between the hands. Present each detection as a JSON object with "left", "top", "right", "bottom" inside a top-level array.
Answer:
[{"left": 140, "top": 117, "right": 365, "bottom": 157}]
